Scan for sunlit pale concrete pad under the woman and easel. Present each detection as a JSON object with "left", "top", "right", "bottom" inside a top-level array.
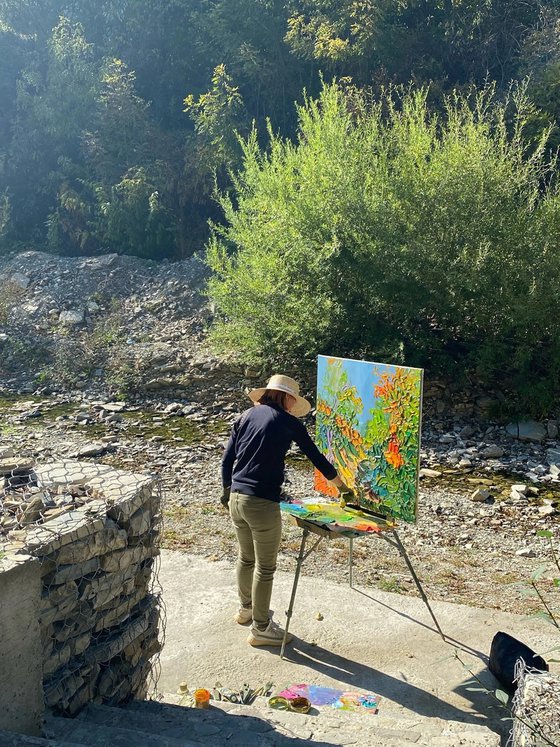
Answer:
[{"left": 158, "top": 551, "right": 558, "bottom": 743}]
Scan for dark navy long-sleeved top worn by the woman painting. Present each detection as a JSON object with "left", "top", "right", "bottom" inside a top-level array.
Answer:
[{"left": 222, "top": 405, "right": 337, "bottom": 502}]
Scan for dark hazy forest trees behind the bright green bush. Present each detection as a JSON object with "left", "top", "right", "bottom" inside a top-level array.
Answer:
[{"left": 0, "top": 0, "right": 560, "bottom": 258}]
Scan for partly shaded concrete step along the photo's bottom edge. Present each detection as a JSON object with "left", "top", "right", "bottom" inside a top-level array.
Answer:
[{"left": 42, "top": 695, "right": 500, "bottom": 747}]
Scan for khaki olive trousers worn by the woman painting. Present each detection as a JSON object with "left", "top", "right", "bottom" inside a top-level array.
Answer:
[{"left": 229, "top": 493, "right": 282, "bottom": 629}]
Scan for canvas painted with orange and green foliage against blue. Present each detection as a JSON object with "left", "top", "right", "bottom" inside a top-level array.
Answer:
[{"left": 315, "top": 355, "right": 423, "bottom": 522}]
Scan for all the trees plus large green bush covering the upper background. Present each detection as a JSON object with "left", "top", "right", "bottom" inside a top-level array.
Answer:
[{"left": 0, "top": 0, "right": 560, "bottom": 412}]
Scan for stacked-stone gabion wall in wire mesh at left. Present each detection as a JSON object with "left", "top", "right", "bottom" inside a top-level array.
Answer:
[{"left": 4, "top": 462, "right": 161, "bottom": 715}]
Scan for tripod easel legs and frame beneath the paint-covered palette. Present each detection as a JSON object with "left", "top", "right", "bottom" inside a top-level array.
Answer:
[{"left": 280, "top": 516, "right": 445, "bottom": 659}]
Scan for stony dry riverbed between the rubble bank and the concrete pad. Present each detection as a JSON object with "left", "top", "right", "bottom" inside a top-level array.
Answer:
[{"left": 0, "top": 397, "right": 559, "bottom": 613}]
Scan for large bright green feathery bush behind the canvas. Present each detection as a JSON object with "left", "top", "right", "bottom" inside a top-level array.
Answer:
[{"left": 208, "top": 84, "right": 560, "bottom": 411}]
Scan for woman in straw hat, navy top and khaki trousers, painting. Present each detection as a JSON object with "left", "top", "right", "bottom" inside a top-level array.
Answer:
[{"left": 222, "top": 374, "right": 351, "bottom": 646}]
